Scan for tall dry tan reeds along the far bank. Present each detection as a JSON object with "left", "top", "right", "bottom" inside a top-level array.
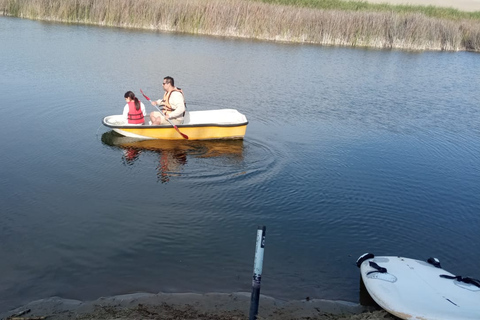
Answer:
[{"left": 0, "top": 0, "right": 480, "bottom": 52}]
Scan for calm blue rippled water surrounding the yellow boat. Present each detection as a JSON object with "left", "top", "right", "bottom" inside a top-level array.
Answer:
[{"left": 0, "top": 17, "right": 480, "bottom": 311}]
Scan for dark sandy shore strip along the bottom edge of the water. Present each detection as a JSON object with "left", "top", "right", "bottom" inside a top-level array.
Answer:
[{"left": 0, "top": 292, "right": 397, "bottom": 320}]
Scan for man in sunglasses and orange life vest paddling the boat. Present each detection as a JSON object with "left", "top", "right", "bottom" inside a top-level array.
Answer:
[{"left": 150, "top": 77, "right": 185, "bottom": 125}]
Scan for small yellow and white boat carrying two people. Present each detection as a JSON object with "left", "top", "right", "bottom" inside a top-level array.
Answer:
[{"left": 103, "top": 109, "right": 248, "bottom": 140}]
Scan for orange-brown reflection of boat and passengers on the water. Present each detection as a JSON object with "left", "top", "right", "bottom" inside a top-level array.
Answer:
[{"left": 102, "top": 131, "right": 243, "bottom": 183}]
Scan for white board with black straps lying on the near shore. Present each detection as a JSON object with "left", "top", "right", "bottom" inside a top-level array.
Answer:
[{"left": 357, "top": 254, "right": 480, "bottom": 320}]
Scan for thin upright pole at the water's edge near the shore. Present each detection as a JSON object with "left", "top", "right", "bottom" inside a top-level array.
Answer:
[{"left": 249, "top": 226, "right": 266, "bottom": 320}]
